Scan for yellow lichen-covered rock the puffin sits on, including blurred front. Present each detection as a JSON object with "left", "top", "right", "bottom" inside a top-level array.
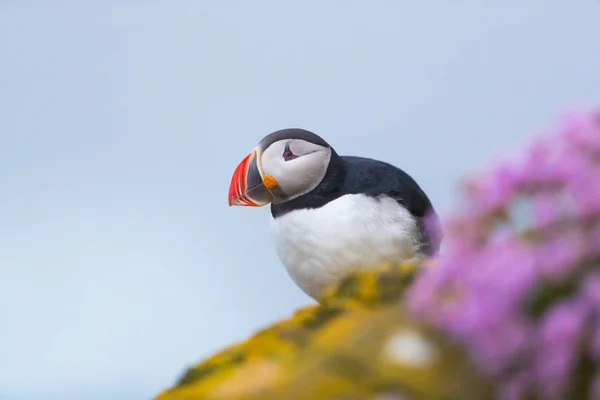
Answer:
[{"left": 156, "top": 263, "right": 488, "bottom": 400}]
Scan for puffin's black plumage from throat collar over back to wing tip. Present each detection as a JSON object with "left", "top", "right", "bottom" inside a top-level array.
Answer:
[{"left": 271, "top": 149, "right": 441, "bottom": 254}]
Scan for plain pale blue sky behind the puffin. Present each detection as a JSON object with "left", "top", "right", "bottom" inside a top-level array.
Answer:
[{"left": 0, "top": 0, "right": 600, "bottom": 400}]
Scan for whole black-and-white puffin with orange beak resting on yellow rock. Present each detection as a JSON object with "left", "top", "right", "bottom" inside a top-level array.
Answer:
[{"left": 228, "top": 128, "right": 443, "bottom": 302}]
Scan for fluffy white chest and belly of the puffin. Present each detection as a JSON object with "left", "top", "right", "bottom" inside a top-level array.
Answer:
[{"left": 271, "top": 194, "right": 418, "bottom": 300}]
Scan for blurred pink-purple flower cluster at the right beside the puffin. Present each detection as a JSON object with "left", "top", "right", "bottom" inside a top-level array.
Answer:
[{"left": 408, "top": 110, "right": 600, "bottom": 399}]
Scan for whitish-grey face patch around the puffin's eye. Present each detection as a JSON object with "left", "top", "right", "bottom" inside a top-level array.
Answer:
[{"left": 261, "top": 139, "right": 331, "bottom": 203}]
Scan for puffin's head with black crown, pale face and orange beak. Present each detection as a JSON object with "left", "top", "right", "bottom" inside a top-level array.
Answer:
[{"left": 229, "top": 129, "right": 333, "bottom": 207}]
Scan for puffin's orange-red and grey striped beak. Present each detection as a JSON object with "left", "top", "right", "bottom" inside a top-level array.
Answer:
[{"left": 229, "top": 149, "right": 276, "bottom": 207}]
